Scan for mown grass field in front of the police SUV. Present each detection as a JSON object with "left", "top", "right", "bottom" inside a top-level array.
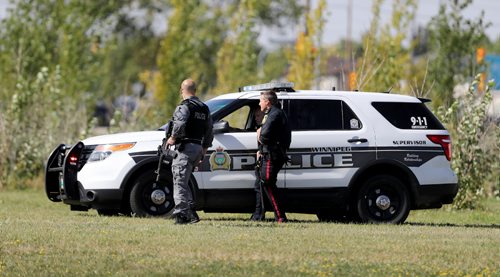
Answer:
[{"left": 0, "top": 191, "right": 500, "bottom": 276}]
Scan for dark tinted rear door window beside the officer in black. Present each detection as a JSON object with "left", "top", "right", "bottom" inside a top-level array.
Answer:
[{"left": 288, "top": 99, "right": 362, "bottom": 131}]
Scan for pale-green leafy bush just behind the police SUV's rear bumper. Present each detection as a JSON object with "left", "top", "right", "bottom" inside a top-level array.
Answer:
[{"left": 437, "top": 75, "right": 499, "bottom": 209}]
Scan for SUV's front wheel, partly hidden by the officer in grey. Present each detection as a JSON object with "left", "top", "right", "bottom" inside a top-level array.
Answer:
[{"left": 130, "top": 169, "right": 175, "bottom": 218}]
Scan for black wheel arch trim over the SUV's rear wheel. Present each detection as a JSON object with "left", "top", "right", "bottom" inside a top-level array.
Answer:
[{"left": 349, "top": 160, "right": 419, "bottom": 208}]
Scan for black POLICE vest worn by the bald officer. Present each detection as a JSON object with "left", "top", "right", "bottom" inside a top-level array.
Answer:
[{"left": 181, "top": 98, "right": 210, "bottom": 141}]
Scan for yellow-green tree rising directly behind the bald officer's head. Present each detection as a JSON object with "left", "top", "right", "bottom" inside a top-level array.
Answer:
[{"left": 154, "top": 0, "right": 225, "bottom": 115}]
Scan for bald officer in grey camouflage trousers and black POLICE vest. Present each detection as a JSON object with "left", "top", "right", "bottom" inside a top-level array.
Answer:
[{"left": 167, "top": 79, "right": 214, "bottom": 224}]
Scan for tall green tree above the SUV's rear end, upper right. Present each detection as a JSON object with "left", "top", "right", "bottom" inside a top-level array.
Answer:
[{"left": 429, "top": 0, "right": 490, "bottom": 108}]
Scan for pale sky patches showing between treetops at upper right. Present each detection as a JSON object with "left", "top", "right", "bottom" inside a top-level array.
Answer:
[{"left": 261, "top": 0, "right": 500, "bottom": 47}]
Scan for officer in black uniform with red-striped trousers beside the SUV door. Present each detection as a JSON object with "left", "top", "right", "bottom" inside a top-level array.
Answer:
[{"left": 251, "top": 91, "right": 291, "bottom": 222}]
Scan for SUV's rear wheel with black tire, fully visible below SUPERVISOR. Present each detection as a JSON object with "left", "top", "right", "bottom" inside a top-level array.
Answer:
[{"left": 356, "top": 175, "right": 410, "bottom": 224}]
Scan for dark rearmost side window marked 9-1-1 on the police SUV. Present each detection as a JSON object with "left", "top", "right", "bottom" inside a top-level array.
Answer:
[{"left": 372, "top": 102, "right": 444, "bottom": 130}]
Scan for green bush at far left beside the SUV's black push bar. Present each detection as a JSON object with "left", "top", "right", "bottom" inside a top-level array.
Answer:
[{"left": 0, "top": 68, "right": 87, "bottom": 189}]
